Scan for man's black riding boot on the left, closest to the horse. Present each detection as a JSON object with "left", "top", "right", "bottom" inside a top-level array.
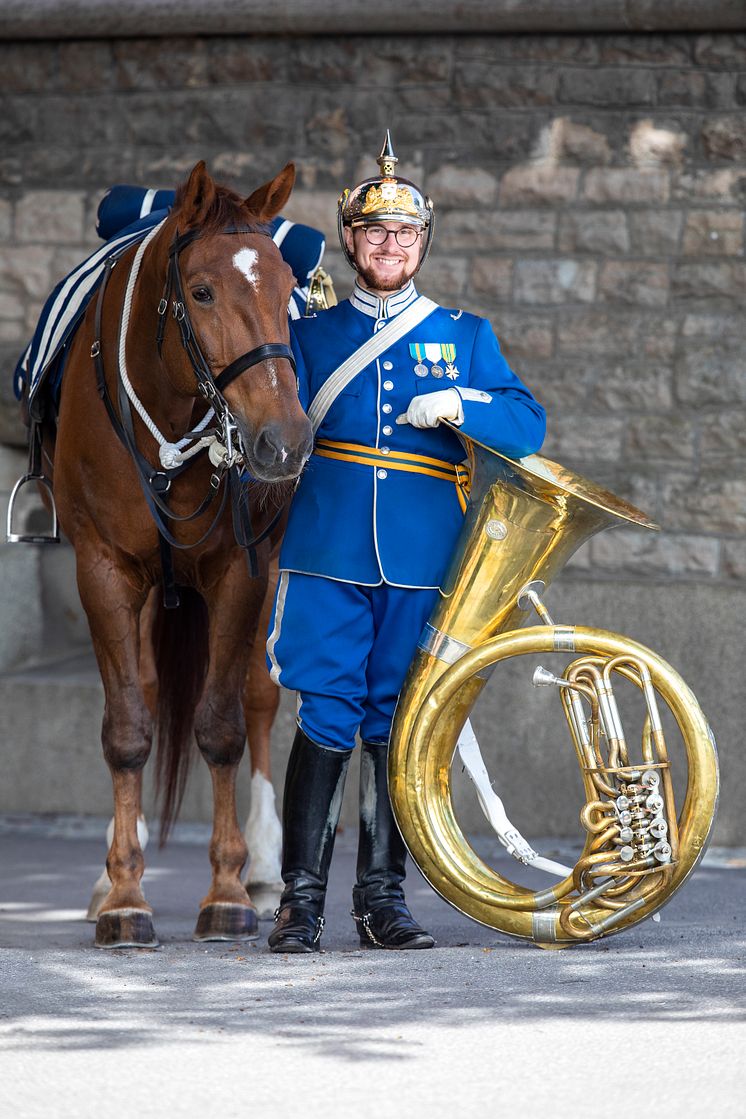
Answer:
[{"left": 268, "top": 728, "right": 350, "bottom": 952}]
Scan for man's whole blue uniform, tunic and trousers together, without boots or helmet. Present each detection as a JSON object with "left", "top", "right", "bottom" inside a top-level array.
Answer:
[{"left": 267, "top": 282, "right": 545, "bottom": 750}]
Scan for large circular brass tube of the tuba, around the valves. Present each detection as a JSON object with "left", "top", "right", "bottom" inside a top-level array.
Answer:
[{"left": 389, "top": 626, "right": 718, "bottom": 947}]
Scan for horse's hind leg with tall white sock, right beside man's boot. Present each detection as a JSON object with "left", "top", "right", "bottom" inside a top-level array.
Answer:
[{"left": 244, "top": 558, "right": 283, "bottom": 918}]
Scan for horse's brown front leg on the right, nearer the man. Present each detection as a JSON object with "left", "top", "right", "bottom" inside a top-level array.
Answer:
[{"left": 195, "top": 568, "right": 262, "bottom": 940}]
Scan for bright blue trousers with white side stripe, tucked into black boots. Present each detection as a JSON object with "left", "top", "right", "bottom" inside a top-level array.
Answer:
[{"left": 267, "top": 572, "right": 438, "bottom": 751}]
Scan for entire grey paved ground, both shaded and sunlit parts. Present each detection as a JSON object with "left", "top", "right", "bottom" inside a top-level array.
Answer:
[{"left": 0, "top": 818, "right": 746, "bottom": 1119}]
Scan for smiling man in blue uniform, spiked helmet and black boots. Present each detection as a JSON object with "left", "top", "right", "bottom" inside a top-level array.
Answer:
[{"left": 267, "top": 133, "right": 545, "bottom": 952}]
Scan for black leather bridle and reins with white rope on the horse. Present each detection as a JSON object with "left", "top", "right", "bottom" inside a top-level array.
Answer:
[{"left": 91, "top": 226, "right": 295, "bottom": 609}]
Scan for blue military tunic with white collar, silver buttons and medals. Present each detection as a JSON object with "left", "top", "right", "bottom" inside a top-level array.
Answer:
[{"left": 280, "top": 281, "right": 545, "bottom": 587}]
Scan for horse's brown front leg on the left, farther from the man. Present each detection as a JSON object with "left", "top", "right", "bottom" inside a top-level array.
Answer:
[{"left": 78, "top": 553, "right": 158, "bottom": 948}]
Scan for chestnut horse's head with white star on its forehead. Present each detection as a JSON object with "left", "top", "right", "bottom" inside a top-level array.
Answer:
[{"left": 163, "top": 162, "right": 312, "bottom": 482}]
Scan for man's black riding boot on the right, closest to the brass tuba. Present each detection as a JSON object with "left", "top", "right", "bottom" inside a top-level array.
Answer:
[{"left": 352, "top": 742, "right": 435, "bottom": 948}]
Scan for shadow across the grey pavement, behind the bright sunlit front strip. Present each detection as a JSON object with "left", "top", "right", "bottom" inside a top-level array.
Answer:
[{"left": 0, "top": 834, "right": 746, "bottom": 1061}]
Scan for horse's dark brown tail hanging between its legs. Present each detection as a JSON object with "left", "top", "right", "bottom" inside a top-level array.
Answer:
[{"left": 152, "top": 586, "right": 208, "bottom": 846}]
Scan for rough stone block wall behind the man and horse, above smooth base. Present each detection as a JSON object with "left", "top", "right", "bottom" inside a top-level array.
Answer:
[{"left": 0, "top": 34, "right": 746, "bottom": 584}]
